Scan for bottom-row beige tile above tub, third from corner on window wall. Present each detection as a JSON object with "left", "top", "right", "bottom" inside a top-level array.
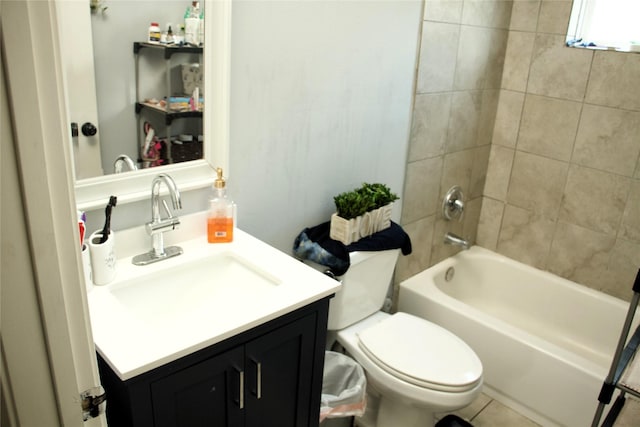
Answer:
[{"left": 547, "top": 222, "right": 615, "bottom": 289}]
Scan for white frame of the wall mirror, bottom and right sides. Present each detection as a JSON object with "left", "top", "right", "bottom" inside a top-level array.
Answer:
[{"left": 75, "top": 0, "right": 232, "bottom": 211}]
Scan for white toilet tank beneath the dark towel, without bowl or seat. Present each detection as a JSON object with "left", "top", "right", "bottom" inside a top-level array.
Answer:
[{"left": 327, "top": 249, "right": 400, "bottom": 331}]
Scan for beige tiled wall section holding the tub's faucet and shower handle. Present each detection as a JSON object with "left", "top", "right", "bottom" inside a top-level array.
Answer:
[{"left": 396, "top": 0, "right": 512, "bottom": 282}]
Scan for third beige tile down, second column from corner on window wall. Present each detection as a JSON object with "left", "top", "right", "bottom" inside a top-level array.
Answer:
[{"left": 518, "top": 95, "right": 582, "bottom": 161}]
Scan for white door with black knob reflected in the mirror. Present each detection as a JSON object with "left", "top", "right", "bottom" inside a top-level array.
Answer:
[{"left": 55, "top": 0, "right": 103, "bottom": 179}]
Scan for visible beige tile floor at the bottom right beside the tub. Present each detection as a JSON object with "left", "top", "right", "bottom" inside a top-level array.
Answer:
[{"left": 443, "top": 393, "right": 640, "bottom": 427}]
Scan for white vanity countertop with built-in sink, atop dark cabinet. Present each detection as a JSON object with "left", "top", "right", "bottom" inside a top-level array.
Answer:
[{"left": 88, "top": 229, "right": 340, "bottom": 380}]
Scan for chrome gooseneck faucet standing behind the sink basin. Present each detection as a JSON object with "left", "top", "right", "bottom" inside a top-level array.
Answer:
[{"left": 132, "top": 174, "right": 182, "bottom": 265}]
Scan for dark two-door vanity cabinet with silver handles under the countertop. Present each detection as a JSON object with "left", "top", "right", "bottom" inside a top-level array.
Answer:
[{"left": 98, "top": 298, "right": 329, "bottom": 427}]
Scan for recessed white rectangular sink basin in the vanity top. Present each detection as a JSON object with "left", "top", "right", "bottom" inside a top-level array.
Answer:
[{"left": 111, "top": 251, "right": 282, "bottom": 326}]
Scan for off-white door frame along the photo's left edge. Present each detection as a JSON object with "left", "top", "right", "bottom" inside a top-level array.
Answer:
[{"left": 0, "top": 0, "right": 106, "bottom": 427}]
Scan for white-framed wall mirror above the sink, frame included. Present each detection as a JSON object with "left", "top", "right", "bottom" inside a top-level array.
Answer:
[{"left": 56, "top": 0, "right": 231, "bottom": 210}]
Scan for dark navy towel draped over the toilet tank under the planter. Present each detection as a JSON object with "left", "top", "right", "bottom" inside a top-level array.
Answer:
[{"left": 293, "top": 221, "right": 411, "bottom": 276}]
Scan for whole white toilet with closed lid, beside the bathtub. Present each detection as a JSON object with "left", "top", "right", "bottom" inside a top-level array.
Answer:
[{"left": 309, "top": 249, "right": 482, "bottom": 427}]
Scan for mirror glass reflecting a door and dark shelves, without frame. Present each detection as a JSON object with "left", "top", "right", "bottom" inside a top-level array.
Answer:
[{"left": 68, "top": 0, "right": 205, "bottom": 179}]
